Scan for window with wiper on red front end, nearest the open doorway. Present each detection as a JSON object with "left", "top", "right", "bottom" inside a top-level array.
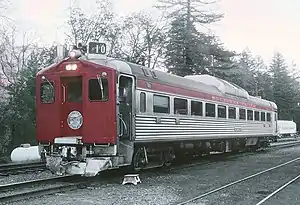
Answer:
[{"left": 89, "top": 78, "right": 108, "bottom": 101}]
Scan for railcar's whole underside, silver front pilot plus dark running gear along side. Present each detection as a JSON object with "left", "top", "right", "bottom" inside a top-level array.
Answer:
[{"left": 44, "top": 137, "right": 269, "bottom": 176}]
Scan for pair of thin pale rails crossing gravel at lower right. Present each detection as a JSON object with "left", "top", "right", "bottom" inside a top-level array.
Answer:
[{"left": 175, "top": 157, "right": 300, "bottom": 205}]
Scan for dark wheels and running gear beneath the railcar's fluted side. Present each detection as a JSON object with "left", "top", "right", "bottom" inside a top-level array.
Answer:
[{"left": 125, "top": 137, "right": 270, "bottom": 171}]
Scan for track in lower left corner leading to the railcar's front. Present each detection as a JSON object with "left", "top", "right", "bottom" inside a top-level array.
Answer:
[{"left": 0, "top": 175, "right": 88, "bottom": 204}]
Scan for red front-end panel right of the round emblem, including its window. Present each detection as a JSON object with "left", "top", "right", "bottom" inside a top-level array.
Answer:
[{"left": 83, "top": 67, "right": 117, "bottom": 144}]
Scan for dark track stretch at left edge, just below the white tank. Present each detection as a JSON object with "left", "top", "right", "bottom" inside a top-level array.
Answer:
[{"left": 0, "top": 162, "right": 46, "bottom": 176}]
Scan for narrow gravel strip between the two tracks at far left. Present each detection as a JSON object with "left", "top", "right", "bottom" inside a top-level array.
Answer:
[{"left": 0, "top": 170, "right": 53, "bottom": 185}]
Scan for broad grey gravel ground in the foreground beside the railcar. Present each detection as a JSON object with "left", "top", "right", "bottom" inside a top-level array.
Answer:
[{"left": 14, "top": 144, "right": 300, "bottom": 205}]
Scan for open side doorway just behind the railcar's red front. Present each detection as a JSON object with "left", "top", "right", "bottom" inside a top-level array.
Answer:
[{"left": 117, "top": 73, "right": 136, "bottom": 141}]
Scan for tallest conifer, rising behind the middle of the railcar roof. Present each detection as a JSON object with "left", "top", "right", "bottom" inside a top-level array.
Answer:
[{"left": 157, "top": 0, "right": 235, "bottom": 77}]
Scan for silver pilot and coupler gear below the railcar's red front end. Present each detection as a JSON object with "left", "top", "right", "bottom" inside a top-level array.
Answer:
[{"left": 44, "top": 145, "right": 128, "bottom": 176}]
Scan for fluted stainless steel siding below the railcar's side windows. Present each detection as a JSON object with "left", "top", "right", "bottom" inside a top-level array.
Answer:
[{"left": 135, "top": 115, "right": 272, "bottom": 142}]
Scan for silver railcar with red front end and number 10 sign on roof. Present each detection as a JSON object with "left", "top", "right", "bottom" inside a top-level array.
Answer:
[{"left": 36, "top": 42, "right": 277, "bottom": 177}]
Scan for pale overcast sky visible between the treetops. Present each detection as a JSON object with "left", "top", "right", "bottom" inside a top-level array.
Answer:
[{"left": 4, "top": 0, "right": 300, "bottom": 66}]
